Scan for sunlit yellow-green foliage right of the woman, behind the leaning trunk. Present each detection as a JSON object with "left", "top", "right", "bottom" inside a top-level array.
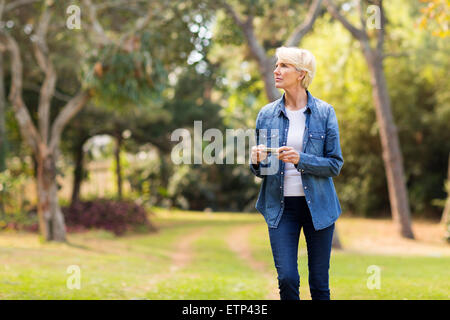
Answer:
[{"left": 296, "top": 2, "right": 450, "bottom": 217}]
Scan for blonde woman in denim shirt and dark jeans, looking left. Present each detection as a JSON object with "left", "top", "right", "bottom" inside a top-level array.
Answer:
[{"left": 250, "top": 47, "right": 344, "bottom": 300}]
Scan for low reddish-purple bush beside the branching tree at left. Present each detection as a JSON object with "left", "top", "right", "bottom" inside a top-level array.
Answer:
[{"left": 62, "top": 199, "right": 156, "bottom": 235}]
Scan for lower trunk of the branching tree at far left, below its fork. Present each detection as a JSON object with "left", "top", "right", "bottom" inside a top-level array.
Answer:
[{"left": 37, "top": 154, "right": 66, "bottom": 242}]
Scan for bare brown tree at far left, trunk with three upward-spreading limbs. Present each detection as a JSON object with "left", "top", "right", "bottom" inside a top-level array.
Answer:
[{"left": 0, "top": 3, "right": 89, "bottom": 241}]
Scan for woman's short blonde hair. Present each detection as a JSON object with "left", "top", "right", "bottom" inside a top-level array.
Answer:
[{"left": 275, "top": 47, "right": 316, "bottom": 89}]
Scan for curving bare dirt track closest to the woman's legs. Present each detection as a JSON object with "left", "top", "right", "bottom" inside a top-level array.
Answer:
[{"left": 227, "top": 225, "right": 280, "bottom": 300}]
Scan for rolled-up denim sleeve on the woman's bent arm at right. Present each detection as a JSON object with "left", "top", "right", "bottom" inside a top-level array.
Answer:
[{"left": 295, "top": 106, "right": 344, "bottom": 177}]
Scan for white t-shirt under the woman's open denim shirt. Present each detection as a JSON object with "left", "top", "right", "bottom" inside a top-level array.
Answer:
[{"left": 284, "top": 106, "right": 306, "bottom": 197}]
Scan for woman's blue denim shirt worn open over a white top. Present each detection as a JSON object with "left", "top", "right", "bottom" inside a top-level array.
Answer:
[{"left": 250, "top": 91, "right": 344, "bottom": 230}]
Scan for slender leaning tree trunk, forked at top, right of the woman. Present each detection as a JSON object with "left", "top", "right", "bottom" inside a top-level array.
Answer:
[{"left": 325, "top": 0, "right": 414, "bottom": 239}]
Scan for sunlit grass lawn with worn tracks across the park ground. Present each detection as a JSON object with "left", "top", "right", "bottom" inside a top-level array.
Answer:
[{"left": 0, "top": 208, "right": 450, "bottom": 300}]
